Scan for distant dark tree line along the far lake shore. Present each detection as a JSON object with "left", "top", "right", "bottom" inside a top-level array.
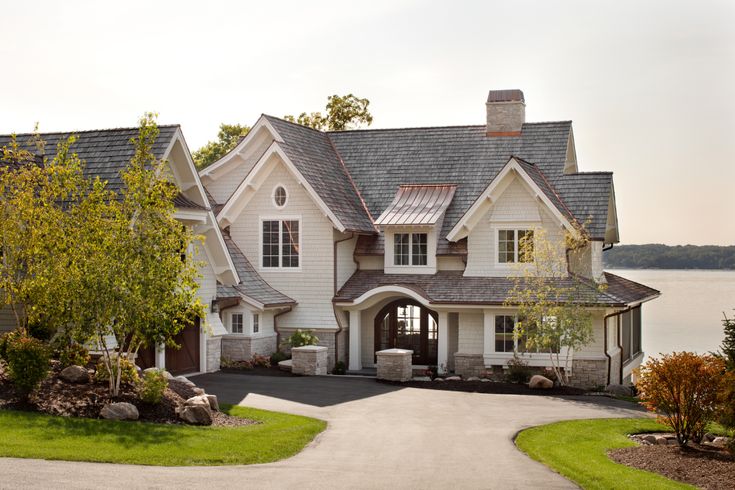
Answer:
[{"left": 602, "top": 243, "right": 735, "bottom": 269}]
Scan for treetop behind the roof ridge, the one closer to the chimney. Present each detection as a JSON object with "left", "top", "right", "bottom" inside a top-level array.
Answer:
[{"left": 283, "top": 94, "right": 373, "bottom": 131}]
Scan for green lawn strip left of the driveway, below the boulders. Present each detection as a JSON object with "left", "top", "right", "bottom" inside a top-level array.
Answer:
[{"left": 0, "top": 406, "right": 326, "bottom": 466}]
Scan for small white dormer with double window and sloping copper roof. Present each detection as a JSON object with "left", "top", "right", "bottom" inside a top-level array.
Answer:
[{"left": 375, "top": 184, "right": 456, "bottom": 274}]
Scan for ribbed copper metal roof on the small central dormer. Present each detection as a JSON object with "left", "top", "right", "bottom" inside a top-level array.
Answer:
[{"left": 375, "top": 184, "right": 457, "bottom": 225}]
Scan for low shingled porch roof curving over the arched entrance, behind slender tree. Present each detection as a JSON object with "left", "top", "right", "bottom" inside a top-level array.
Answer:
[{"left": 334, "top": 270, "right": 659, "bottom": 307}]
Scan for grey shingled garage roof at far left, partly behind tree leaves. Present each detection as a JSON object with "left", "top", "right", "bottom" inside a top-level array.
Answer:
[{"left": 0, "top": 125, "right": 179, "bottom": 192}]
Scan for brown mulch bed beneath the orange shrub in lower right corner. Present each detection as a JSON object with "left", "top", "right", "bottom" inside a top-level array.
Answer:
[{"left": 609, "top": 443, "right": 735, "bottom": 490}]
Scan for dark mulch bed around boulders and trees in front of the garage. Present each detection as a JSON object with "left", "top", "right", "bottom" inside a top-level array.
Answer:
[{"left": 0, "top": 362, "right": 257, "bottom": 427}]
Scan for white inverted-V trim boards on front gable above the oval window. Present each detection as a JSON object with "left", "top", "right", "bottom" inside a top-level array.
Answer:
[{"left": 217, "top": 141, "right": 346, "bottom": 232}]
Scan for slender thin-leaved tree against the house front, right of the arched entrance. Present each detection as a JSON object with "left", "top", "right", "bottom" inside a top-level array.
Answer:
[{"left": 505, "top": 227, "right": 593, "bottom": 385}]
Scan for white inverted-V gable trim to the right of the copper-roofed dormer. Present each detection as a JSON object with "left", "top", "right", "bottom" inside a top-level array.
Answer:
[{"left": 447, "top": 157, "right": 577, "bottom": 242}]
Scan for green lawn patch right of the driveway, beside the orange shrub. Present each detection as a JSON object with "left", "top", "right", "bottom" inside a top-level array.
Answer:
[{"left": 516, "top": 419, "right": 693, "bottom": 490}]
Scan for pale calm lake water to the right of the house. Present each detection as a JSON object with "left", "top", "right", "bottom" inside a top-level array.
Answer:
[{"left": 610, "top": 269, "right": 735, "bottom": 356}]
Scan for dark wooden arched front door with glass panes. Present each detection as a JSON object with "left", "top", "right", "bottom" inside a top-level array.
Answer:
[{"left": 375, "top": 299, "right": 439, "bottom": 365}]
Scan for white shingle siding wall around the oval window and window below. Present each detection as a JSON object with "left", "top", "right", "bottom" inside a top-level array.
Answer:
[{"left": 230, "top": 159, "right": 337, "bottom": 329}]
